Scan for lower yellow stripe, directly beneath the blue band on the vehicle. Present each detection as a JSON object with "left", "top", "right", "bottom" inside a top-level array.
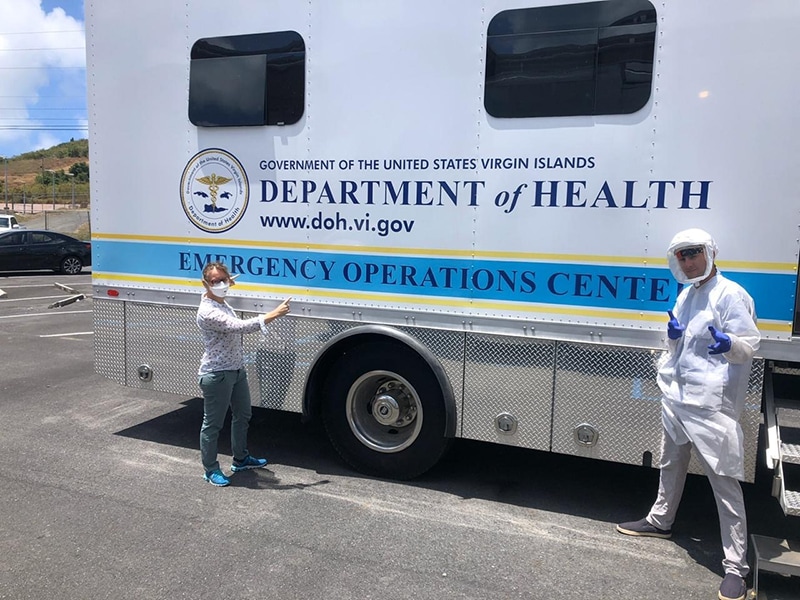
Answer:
[{"left": 92, "top": 273, "right": 792, "bottom": 334}]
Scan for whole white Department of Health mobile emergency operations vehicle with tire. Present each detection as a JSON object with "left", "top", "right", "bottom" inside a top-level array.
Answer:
[{"left": 86, "top": 0, "right": 800, "bottom": 514}]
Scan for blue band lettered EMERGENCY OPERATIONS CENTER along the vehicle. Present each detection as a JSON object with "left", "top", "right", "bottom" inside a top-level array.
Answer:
[{"left": 92, "top": 240, "right": 797, "bottom": 321}]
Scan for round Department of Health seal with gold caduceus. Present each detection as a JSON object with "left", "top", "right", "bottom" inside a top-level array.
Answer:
[{"left": 181, "top": 148, "right": 250, "bottom": 233}]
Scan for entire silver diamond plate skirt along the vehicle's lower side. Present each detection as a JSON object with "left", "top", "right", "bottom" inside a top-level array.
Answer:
[{"left": 94, "top": 298, "right": 764, "bottom": 481}]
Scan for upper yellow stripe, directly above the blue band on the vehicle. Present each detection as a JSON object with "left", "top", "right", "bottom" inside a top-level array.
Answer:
[{"left": 92, "top": 232, "right": 797, "bottom": 273}]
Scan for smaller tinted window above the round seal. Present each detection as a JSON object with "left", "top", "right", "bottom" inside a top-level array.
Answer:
[{"left": 189, "top": 31, "right": 306, "bottom": 127}]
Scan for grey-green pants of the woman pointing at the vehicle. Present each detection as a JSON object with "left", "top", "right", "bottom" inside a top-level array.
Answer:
[{"left": 199, "top": 369, "right": 252, "bottom": 472}]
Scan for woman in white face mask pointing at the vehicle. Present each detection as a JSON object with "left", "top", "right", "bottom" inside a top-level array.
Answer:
[{"left": 197, "top": 262, "right": 289, "bottom": 487}]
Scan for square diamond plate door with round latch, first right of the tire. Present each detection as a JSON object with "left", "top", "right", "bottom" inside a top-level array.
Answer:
[{"left": 462, "top": 334, "right": 555, "bottom": 450}]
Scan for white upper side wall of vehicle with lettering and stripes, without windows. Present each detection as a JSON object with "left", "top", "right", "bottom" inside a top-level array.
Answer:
[{"left": 88, "top": 1, "right": 800, "bottom": 358}]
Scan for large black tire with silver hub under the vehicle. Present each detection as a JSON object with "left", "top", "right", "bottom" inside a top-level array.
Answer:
[{"left": 322, "top": 342, "right": 450, "bottom": 479}]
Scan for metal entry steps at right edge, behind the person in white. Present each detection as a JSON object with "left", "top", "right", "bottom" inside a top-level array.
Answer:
[{"left": 764, "top": 362, "right": 800, "bottom": 517}]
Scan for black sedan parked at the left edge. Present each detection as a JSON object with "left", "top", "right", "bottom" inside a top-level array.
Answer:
[{"left": 0, "top": 229, "right": 92, "bottom": 275}]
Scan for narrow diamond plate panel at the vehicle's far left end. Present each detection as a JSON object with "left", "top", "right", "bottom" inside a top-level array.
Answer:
[{"left": 92, "top": 298, "right": 125, "bottom": 385}]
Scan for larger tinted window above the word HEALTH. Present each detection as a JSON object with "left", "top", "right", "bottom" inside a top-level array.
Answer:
[{"left": 484, "top": 0, "right": 656, "bottom": 117}]
